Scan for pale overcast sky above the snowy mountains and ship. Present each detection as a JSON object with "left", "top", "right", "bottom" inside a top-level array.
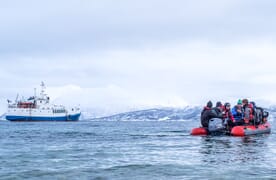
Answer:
[{"left": 0, "top": 0, "right": 276, "bottom": 113}]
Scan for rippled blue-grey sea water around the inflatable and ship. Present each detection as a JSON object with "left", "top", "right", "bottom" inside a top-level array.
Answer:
[{"left": 0, "top": 119, "right": 276, "bottom": 180}]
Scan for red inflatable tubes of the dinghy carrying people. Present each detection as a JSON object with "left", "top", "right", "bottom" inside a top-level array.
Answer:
[{"left": 191, "top": 122, "right": 271, "bottom": 136}]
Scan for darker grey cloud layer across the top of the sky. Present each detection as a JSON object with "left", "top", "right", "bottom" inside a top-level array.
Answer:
[{"left": 0, "top": 0, "right": 276, "bottom": 55}]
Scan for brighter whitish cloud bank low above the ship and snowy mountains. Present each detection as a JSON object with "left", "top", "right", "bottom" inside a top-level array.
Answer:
[{"left": 0, "top": 40, "right": 276, "bottom": 115}]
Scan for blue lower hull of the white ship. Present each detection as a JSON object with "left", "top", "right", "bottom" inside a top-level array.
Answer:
[{"left": 6, "top": 113, "right": 80, "bottom": 121}]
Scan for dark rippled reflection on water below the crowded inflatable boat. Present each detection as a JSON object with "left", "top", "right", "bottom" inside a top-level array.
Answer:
[{"left": 199, "top": 135, "right": 267, "bottom": 164}]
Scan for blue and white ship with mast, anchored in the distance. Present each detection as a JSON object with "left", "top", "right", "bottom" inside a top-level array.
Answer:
[{"left": 6, "top": 82, "right": 81, "bottom": 121}]
